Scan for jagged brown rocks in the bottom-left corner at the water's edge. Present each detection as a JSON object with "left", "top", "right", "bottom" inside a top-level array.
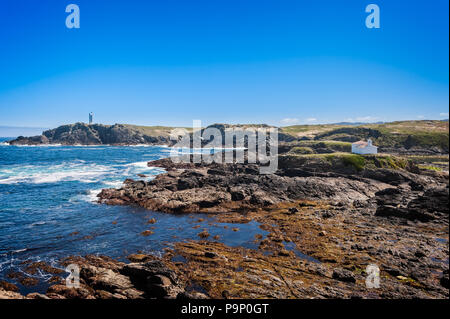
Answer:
[{"left": 0, "top": 255, "right": 185, "bottom": 299}]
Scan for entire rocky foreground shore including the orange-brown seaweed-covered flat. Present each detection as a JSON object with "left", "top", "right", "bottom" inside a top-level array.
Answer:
[{"left": 0, "top": 156, "right": 449, "bottom": 299}]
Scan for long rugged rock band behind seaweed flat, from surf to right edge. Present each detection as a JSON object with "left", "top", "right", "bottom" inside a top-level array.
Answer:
[{"left": 98, "top": 157, "right": 448, "bottom": 221}]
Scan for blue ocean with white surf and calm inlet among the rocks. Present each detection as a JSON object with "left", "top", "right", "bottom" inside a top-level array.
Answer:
[{"left": 0, "top": 138, "right": 267, "bottom": 293}]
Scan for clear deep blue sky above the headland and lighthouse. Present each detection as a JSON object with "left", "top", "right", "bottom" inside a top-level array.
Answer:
[{"left": 0, "top": 0, "right": 449, "bottom": 128}]
